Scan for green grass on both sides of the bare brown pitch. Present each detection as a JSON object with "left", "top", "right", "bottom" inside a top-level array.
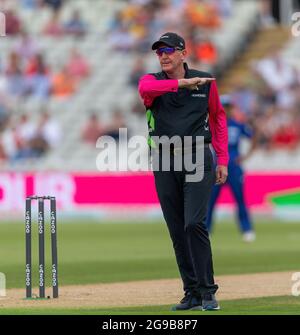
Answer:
[{"left": 0, "top": 221, "right": 300, "bottom": 314}]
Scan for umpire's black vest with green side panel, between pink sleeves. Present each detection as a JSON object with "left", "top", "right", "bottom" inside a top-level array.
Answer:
[{"left": 146, "top": 63, "right": 212, "bottom": 146}]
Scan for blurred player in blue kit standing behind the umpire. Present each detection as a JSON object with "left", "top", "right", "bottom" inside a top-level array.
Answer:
[{"left": 206, "top": 95, "right": 256, "bottom": 242}]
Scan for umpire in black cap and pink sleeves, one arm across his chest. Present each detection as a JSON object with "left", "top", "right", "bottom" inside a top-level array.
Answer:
[{"left": 139, "top": 32, "right": 228, "bottom": 310}]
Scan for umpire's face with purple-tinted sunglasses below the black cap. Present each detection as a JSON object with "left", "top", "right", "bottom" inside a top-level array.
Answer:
[{"left": 156, "top": 44, "right": 186, "bottom": 72}]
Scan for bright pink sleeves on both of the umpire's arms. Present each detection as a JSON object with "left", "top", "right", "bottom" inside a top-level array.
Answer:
[{"left": 138, "top": 74, "right": 229, "bottom": 166}]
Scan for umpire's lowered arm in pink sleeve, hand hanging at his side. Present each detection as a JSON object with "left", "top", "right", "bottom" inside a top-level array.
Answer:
[{"left": 208, "top": 81, "right": 229, "bottom": 184}]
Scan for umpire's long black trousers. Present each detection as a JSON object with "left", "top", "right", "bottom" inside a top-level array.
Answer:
[{"left": 154, "top": 146, "right": 218, "bottom": 294}]
